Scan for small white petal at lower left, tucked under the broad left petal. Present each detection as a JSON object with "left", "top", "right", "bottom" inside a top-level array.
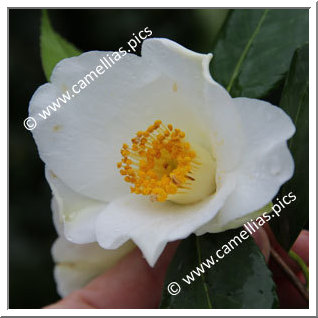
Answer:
[{"left": 45, "top": 167, "right": 107, "bottom": 244}]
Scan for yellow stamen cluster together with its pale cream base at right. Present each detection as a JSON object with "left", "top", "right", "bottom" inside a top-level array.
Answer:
[{"left": 117, "top": 120, "right": 215, "bottom": 204}]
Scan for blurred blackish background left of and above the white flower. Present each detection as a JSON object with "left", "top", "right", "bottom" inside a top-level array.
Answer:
[{"left": 9, "top": 9, "right": 227, "bottom": 309}]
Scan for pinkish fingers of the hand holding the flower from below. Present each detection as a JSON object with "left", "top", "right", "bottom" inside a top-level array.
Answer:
[{"left": 45, "top": 227, "right": 309, "bottom": 309}]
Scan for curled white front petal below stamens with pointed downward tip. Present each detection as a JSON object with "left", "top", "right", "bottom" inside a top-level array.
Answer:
[{"left": 96, "top": 177, "right": 233, "bottom": 266}]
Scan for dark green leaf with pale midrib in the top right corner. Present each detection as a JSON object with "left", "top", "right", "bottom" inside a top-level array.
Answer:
[{"left": 211, "top": 9, "right": 308, "bottom": 98}]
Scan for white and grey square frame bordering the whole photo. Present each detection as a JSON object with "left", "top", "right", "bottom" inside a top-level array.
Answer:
[{"left": 0, "top": 0, "right": 316, "bottom": 317}]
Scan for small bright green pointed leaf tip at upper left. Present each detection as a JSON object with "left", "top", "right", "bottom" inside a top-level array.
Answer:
[{"left": 40, "top": 10, "right": 82, "bottom": 81}]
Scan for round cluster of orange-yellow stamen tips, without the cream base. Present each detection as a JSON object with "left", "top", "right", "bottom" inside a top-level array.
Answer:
[{"left": 117, "top": 120, "right": 200, "bottom": 202}]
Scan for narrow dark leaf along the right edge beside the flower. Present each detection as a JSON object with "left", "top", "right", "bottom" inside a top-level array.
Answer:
[{"left": 270, "top": 44, "right": 309, "bottom": 250}]
